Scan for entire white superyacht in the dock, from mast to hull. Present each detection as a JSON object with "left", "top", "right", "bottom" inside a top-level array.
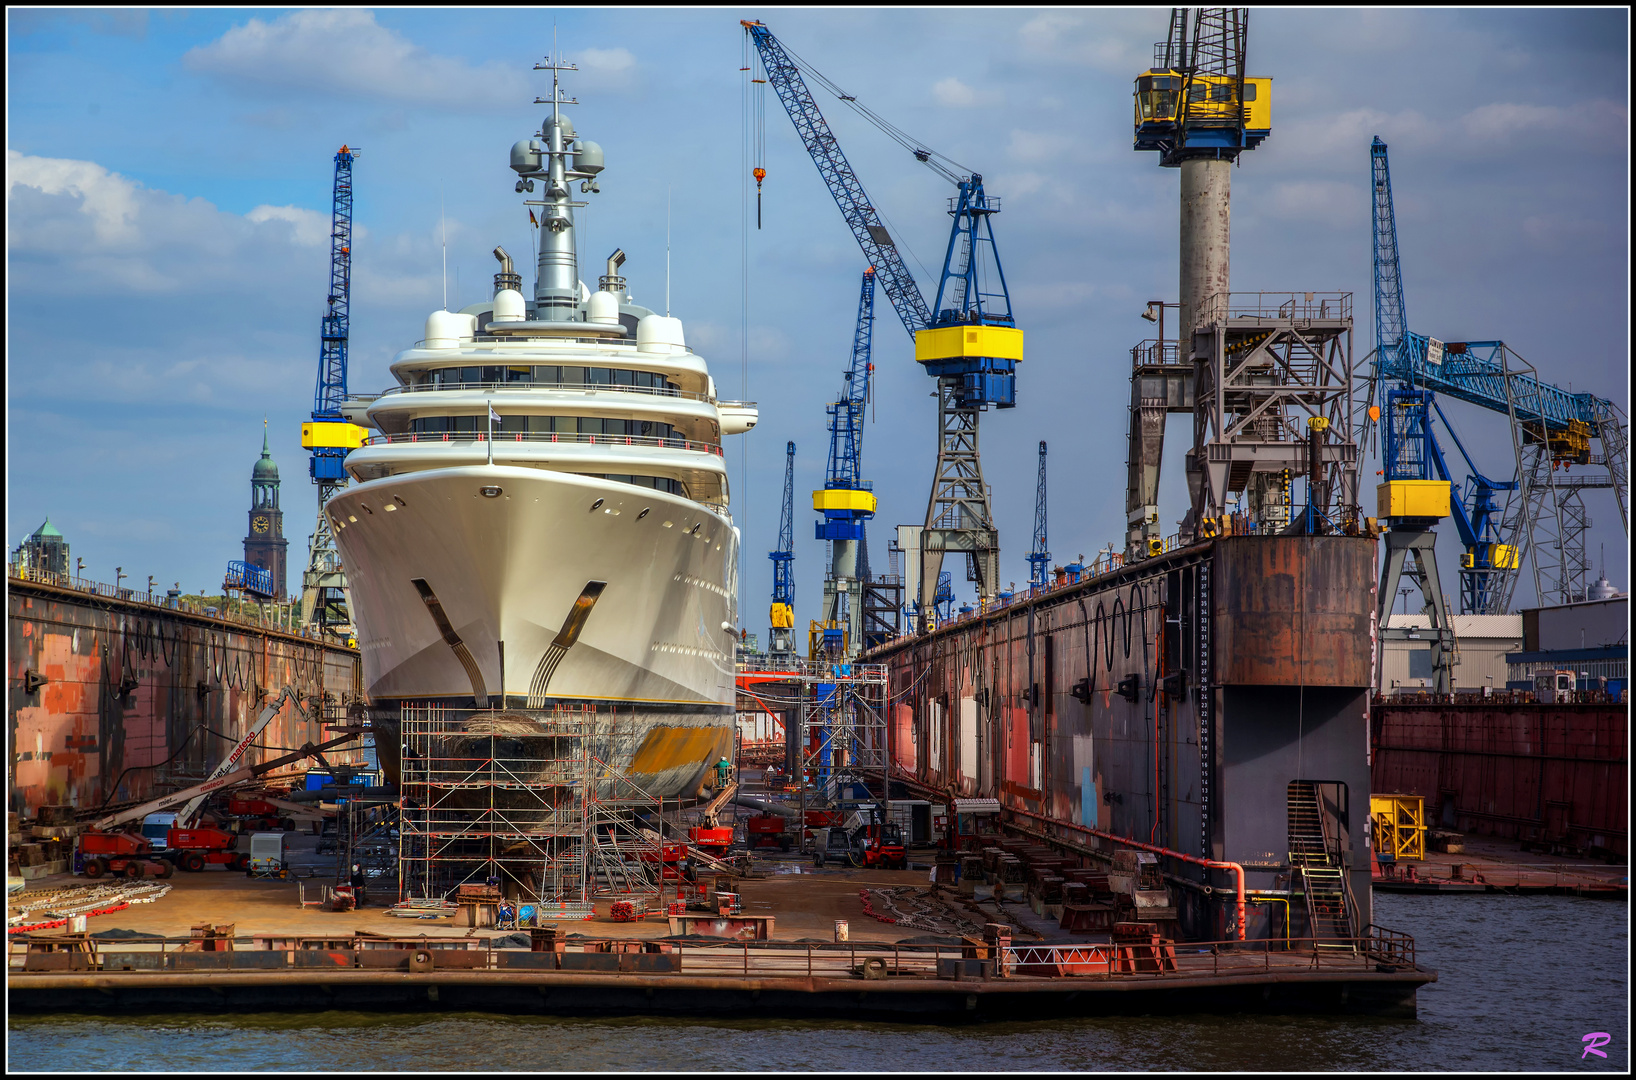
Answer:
[{"left": 327, "top": 62, "right": 756, "bottom": 797}]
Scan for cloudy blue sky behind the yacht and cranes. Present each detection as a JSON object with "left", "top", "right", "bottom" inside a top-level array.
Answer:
[{"left": 7, "top": 8, "right": 1629, "bottom": 618}]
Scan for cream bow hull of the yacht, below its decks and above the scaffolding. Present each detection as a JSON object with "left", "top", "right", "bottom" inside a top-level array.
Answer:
[{"left": 329, "top": 465, "right": 738, "bottom": 797}]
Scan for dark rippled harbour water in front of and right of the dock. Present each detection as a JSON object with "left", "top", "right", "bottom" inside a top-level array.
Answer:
[{"left": 8, "top": 895, "right": 1629, "bottom": 1072}]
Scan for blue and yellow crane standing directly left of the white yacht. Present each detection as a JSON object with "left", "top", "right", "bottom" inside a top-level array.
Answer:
[{"left": 301, "top": 146, "right": 368, "bottom": 637}]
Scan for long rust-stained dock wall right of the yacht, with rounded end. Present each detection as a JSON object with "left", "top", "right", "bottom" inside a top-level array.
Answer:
[{"left": 864, "top": 535, "right": 1376, "bottom": 939}]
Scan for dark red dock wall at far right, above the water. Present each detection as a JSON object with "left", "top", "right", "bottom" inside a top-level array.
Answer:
[{"left": 1371, "top": 699, "right": 1629, "bottom": 856}]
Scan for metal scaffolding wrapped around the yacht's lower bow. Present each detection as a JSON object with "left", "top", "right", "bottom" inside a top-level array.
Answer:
[{"left": 398, "top": 705, "right": 664, "bottom": 908}]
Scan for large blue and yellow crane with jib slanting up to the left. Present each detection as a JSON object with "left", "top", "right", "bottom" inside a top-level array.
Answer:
[{"left": 743, "top": 21, "right": 1023, "bottom": 630}]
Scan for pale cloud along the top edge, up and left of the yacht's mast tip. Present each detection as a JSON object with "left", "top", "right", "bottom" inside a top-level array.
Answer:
[{"left": 182, "top": 8, "right": 530, "bottom": 108}]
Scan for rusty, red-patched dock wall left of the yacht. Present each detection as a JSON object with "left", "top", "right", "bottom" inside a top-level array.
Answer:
[{"left": 7, "top": 578, "right": 362, "bottom": 817}]
